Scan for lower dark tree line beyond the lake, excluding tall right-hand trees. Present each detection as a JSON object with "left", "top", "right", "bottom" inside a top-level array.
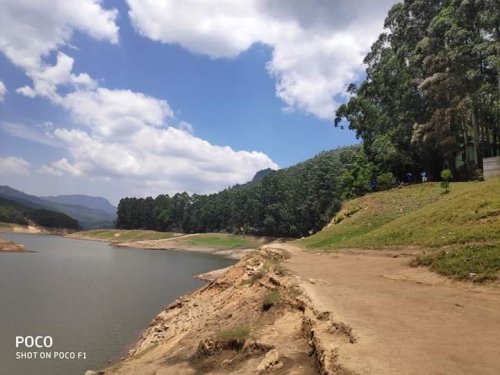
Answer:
[{"left": 117, "top": 147, "right": 373, "bottom": 237}]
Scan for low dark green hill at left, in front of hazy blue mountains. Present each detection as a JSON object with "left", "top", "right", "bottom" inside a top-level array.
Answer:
[{"left": 0, "top": 198, "right": 80, "bottom": 229}]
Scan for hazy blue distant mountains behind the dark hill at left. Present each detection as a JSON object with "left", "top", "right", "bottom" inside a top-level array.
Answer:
[{"left": 0, "top": 186, "right": 116, "bottom": 229}]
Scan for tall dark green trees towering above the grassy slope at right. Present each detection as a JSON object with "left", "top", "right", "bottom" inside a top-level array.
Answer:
[{"left": 335, "top": 0, "right": 500, "bottom": 178}]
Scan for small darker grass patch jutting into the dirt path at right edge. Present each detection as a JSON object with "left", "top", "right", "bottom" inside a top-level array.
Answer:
[{"left": 413, "top": 244, "right": 500, "bottom": 282}]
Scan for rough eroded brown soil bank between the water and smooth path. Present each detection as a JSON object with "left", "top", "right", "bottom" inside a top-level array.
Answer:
[{"left": 104, "top": 250, "right": 317, "bottom": 375}]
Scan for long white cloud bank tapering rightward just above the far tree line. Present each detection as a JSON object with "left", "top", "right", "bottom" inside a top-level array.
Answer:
[{"left": 41, "top": 106, "right": 278, "bottom": 193}]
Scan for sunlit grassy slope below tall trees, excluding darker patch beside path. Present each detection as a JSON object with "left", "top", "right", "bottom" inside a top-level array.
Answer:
[{"left": 297, "top": 178, "right": 500, "bottom": 250}]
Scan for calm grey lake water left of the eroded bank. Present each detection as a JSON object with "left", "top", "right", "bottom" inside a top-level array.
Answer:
[{"left": 0, "top": 233, "right": 234, "bottom": 375}]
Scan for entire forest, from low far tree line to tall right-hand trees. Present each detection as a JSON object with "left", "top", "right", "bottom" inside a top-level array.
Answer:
[{"left": 116, "top": 0, "right": 500, "bottom": 237}]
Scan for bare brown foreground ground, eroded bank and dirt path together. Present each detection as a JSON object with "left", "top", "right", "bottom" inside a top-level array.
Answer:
[{"left": 89, "top": 243, "right": 500, "bottom": 375}]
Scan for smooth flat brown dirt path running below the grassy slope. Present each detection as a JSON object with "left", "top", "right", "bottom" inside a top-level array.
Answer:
[{"left": 280, "top": 244, "right": 500, "bottom": 375}]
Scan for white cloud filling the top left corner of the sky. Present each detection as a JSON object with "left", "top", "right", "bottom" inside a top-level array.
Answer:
[{"left": 0, "top": 0, "right": 118, "bottom": 71}]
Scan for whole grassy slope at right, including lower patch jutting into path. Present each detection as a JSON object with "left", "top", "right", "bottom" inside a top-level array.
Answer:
[{"left": 298, "top": 178, "right": 500, "bottom": 280}]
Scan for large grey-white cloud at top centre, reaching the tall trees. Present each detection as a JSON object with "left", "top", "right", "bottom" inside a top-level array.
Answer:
[{"left": 127, "top": 0, "right": 395, "bottom": 119}]
